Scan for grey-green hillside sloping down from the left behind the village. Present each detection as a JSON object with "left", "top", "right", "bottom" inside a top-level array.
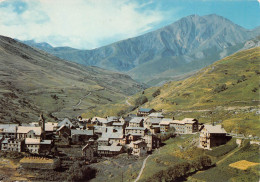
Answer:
[{"left": 0, "top": 36, "right": 143, "bottom": 122}]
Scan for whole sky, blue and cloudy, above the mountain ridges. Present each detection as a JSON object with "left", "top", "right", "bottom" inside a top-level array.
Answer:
[{"left": 0, "top": 0, "right": 260, "bottom": 49}]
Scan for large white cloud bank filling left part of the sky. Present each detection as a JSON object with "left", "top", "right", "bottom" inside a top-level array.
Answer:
[{"left": 0, "top": 0, "right": 165, "bottom": 49}]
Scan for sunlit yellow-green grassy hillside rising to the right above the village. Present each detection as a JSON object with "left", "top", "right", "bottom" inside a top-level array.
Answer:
[{"left": 107, "top": 47, "right": 260, "bottom": 135}]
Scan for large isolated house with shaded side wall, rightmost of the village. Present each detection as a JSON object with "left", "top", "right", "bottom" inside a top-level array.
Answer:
[{"left": 199, "top": 125, "right": 227, "bottom": 150}]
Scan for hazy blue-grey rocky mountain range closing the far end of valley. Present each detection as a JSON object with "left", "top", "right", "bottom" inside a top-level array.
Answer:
[{"left": 21, "top": 14, "right": 260, "bottom": 85}]
